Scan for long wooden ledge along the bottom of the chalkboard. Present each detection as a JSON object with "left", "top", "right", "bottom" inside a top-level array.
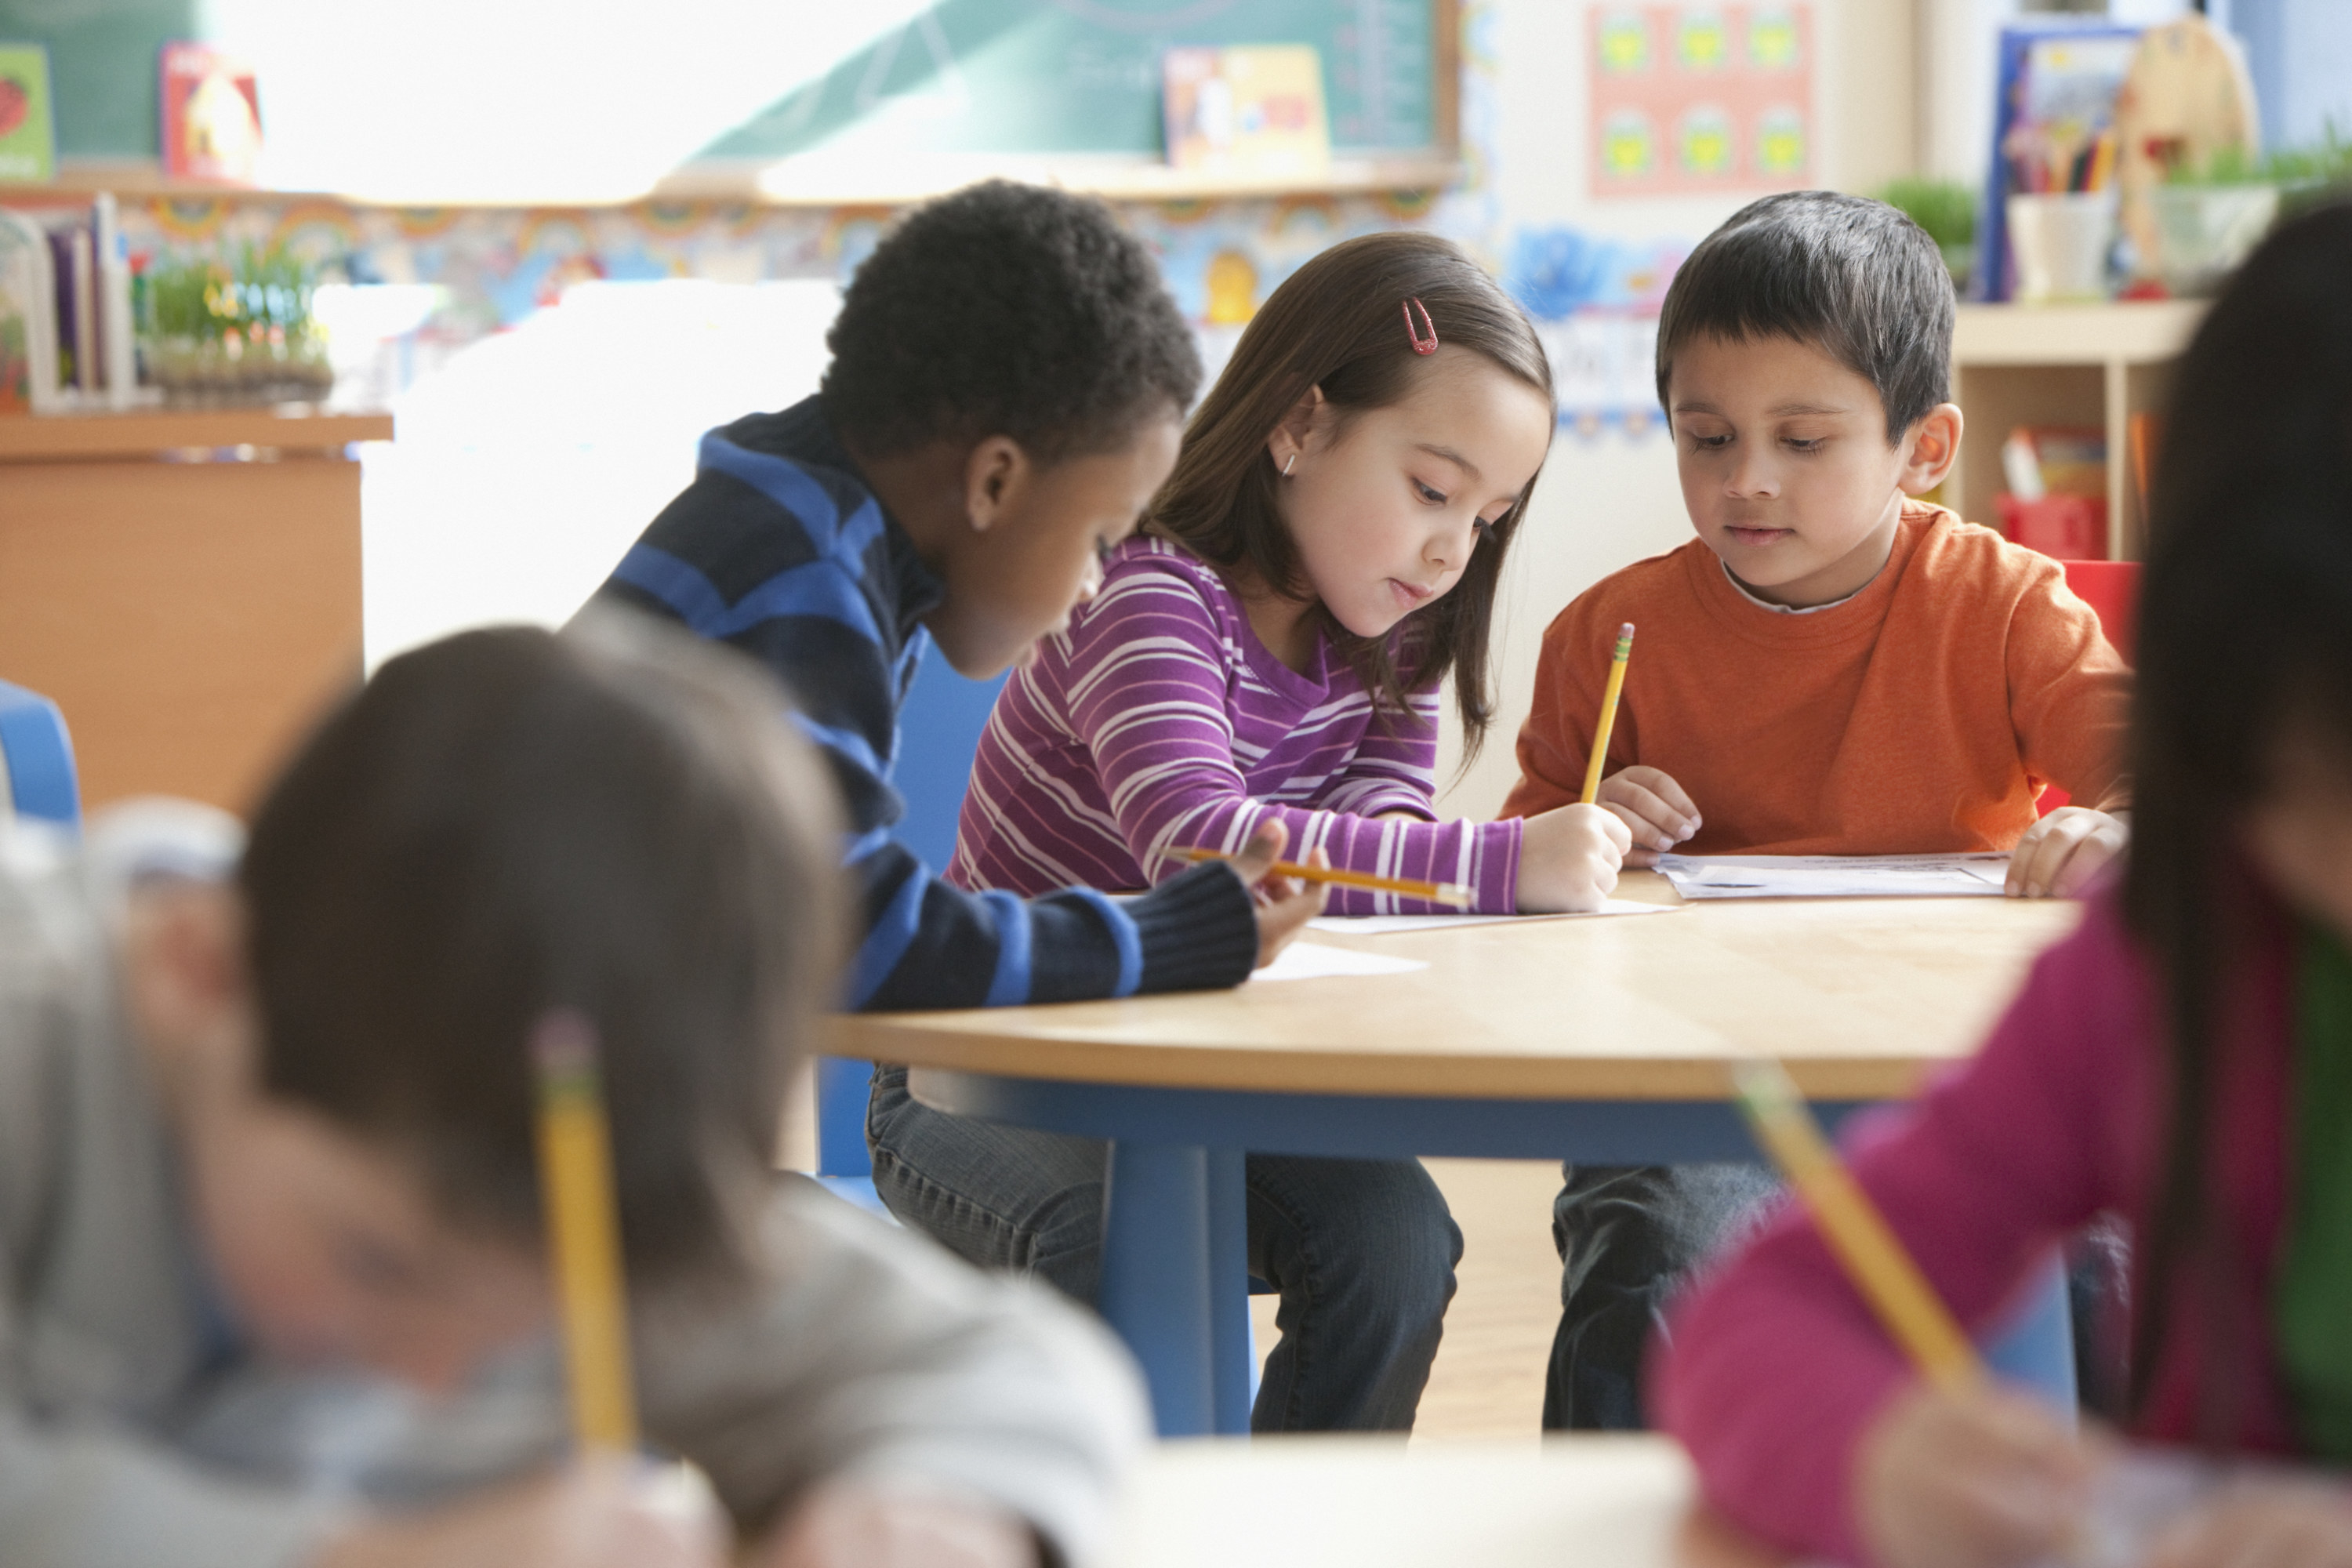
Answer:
[{"left": 0, "top": 153, "right": 1463, "bottom": 209}]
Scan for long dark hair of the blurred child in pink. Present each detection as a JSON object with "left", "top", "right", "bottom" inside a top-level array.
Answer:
[{"left": 2124, "top": 205, "right": 2352, "bottom": 1441}]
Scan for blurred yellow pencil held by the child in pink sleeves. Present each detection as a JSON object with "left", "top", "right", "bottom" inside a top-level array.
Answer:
[{"left": 1731, "top": 1060, "right": 1985, "bottom": 1394}]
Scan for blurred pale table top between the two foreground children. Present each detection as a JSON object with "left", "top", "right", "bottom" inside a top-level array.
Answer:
[{"left": 1110, "top": 1436, "right": 1783, "bottom": 1568}]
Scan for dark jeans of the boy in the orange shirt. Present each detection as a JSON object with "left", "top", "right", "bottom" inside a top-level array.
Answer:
[{"left": 1543, "top": 1163, "right": 1780, "bottom": 1432}]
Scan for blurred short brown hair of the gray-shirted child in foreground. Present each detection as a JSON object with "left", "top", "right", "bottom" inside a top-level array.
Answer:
[{"left": 240, "top": 612, "right": 847, "bottom": 1281}]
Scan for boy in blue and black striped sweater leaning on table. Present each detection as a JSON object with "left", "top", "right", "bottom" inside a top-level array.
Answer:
[{"left": 600, "top": 181, "right": 1319, "bottom": 1008}]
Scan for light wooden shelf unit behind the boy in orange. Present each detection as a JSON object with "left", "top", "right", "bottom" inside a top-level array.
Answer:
[{"left": 1945, "top": 299, "right": 2206, "bottom": 560}]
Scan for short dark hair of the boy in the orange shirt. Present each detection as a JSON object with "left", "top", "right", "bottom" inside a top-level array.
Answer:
[{"left": 1658, "top": 191, "right": 1957, "bottom": 445}]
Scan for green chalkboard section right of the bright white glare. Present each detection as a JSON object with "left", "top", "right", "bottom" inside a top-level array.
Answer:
[{"left": 701, "top": 0, "right": 1449, "bottom": 160}]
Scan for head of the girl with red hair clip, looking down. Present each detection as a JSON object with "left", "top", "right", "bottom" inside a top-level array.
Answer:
[{"left": 1152, "top": 233, "right": 1552, "bottom": 746}]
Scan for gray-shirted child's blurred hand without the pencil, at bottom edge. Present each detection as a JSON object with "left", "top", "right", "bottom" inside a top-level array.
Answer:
[{"left": 750, "top": 1481, "right": 1040, "bottom": 1568}]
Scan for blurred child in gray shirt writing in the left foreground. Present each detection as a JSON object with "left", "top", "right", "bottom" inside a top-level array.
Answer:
[{"left": 0, "top": 623, "right": 1143, "bottom": 1568}]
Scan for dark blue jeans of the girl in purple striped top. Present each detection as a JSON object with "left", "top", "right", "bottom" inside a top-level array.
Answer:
[{"left": 866, "top": 1067, "right": 1463, "bottom": 1432}]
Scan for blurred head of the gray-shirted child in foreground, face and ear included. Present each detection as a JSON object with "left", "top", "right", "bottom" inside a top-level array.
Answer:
[{"left": 127, "top": 619, "right": 842, "bottom": 1385}]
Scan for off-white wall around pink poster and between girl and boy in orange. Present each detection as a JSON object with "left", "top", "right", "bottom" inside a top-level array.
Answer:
[{"left": 1442, "top": 0, "right": 1919, "bottom": 815}]
